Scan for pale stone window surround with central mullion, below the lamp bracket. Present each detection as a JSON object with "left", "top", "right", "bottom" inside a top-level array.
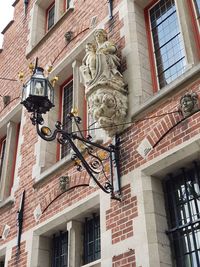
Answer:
[{"left": 30, "top": 193, "right": 102, "bottom": 267}]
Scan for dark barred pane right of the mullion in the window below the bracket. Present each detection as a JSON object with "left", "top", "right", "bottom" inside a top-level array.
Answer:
[{"left": 84, "top": 215, "right": 101, "bottom": 264}]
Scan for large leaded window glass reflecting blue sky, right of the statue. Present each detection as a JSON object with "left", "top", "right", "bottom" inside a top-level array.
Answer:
[{"left": 150, "top": 0, "right": 186, "bottom": 88}]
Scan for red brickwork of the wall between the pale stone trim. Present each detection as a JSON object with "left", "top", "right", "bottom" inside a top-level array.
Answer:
[{"left": 0, "top": 0, "right": 200, "bottom": 267}]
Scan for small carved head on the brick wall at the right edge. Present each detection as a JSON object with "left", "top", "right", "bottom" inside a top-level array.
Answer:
[{"left": 180, "top": 93, "right": 199, "bottom": 118}]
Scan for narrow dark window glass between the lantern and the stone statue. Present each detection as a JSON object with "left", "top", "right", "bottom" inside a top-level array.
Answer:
[{"left": 61, "top": 82, "right": 73, "bottom": 158}]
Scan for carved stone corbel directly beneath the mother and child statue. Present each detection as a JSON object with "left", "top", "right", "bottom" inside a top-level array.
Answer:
[{"left": 89, "top": 89, "right": 127, "bottom": 137}]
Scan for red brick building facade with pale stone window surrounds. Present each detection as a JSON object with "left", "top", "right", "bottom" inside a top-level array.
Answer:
[{"left": 0, "top": 0, "right": 200, "bottom": 267}]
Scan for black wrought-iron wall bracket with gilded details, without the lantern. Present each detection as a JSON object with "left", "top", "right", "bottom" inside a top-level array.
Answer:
[{"left": 31, "top": 112, "right": 121, "bottom": 201}]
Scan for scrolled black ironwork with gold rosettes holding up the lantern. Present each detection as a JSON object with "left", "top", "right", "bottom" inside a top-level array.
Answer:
[{"left": 31, "top": 112, "right": 121, "bottom": 201}]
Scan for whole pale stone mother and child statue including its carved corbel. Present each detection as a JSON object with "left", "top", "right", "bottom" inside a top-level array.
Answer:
[{"left": 80, "top": 29, "right": 128, "bottom": 137}]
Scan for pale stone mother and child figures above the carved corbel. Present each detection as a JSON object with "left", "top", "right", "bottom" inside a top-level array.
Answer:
[{"left": 80, "top": 29, "right": 124, "bottom": 91}]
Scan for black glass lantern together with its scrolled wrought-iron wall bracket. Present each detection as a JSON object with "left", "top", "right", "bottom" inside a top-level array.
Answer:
[{"left": 21, "top": 60, "right": 121, "bottom": 200}]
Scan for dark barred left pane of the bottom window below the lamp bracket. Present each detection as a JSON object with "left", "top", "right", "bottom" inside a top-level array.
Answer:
[{"left": 52, "top": 232, "right": 68, "bottom": 267}]
